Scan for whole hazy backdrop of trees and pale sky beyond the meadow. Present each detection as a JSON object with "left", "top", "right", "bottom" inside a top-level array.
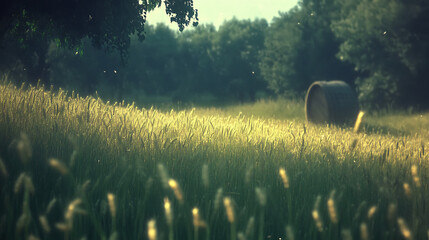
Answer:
[{"left": 0, "top": 0, "right": 429, "bottom": 110}]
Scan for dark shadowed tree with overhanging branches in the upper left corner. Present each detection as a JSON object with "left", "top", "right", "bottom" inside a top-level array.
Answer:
[{"left": 0, "top": 0, "right": 198, "bottom": 83}]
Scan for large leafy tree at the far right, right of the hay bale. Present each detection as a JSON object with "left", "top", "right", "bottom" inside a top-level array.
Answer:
[{"left": 332, "top": 0, "right": 429, "bottom": 107}]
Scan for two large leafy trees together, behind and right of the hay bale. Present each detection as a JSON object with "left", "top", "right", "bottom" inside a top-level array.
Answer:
[{"left": 260, "top": 0, "right": 429, "bottom": 107}]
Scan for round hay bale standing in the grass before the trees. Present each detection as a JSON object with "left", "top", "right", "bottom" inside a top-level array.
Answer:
[{"left": 305, "top": 81, "right": 359, "bottom": 125}]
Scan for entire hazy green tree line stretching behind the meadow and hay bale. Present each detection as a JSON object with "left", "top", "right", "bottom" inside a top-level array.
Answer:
[{"left": 2, "top": 0, "right": 429, "bottom": 108}]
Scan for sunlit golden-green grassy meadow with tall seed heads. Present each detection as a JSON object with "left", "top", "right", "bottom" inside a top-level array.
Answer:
[{"left": 0, "top": 83, "right": 429, "bottom": 240}]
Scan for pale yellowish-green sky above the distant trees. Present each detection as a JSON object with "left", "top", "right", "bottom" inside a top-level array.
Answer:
[{"left": 147, "top": 0, "right": 298, "bottom": 29}]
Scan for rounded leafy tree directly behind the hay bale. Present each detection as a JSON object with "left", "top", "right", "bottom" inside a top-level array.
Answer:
[{"left": 260, "top": 0, "right": 354, "bottom": 97}]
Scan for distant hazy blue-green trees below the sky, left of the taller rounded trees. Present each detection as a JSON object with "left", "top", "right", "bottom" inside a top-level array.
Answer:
[{"left": 48, "top": 20, "right": 267, "bottom": 104}]
